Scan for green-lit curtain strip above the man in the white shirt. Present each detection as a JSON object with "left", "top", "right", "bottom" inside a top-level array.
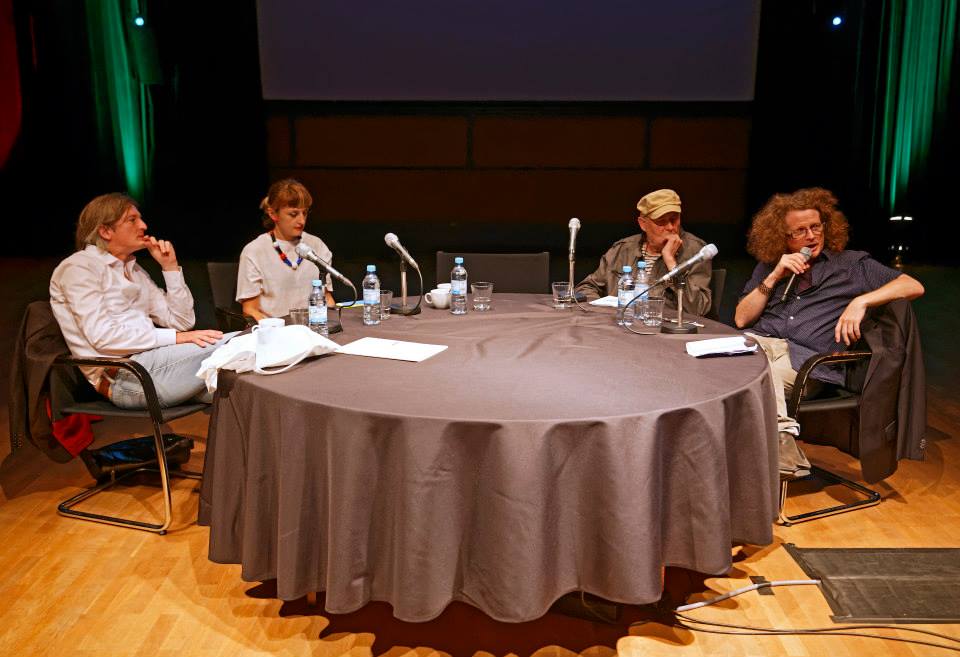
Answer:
[{"left": 86, "top": 0, "right": 154, "bottom": 200}]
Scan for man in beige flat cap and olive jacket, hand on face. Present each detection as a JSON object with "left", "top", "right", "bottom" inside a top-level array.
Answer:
[{"left": 576, "top": 189, "right": 712, "bottom": 315}]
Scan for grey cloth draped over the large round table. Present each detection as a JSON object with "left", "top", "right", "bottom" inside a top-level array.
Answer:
[{"left": 199, "top": 294, "right": 778, "bottom": 621}]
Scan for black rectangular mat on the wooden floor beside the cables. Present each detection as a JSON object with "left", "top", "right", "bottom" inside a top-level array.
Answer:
[{"left": 784, "top": 543, "right": 960, "bottom": 623}]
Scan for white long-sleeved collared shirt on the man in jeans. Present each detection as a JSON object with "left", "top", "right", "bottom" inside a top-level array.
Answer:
[{"left": 50, "top": 245, "right": 196, "bottom": 387}]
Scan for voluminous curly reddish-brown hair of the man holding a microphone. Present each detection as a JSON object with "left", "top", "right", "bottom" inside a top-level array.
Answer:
[{"left": 747, "top": 187, "right": 850, "bottom": 265}]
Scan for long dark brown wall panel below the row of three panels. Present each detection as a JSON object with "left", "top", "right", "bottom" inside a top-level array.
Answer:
[{"left": 274, "top": 169, "right": 745, "bottom": 224}]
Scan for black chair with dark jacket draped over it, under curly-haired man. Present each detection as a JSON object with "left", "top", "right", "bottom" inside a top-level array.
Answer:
[{"left": 779, "top": 300, "right": 926, "bottom": 526}]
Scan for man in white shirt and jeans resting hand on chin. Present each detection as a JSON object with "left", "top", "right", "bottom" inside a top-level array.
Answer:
[{"left": 50, "top": 193, "right": 224, "bottom": 409}]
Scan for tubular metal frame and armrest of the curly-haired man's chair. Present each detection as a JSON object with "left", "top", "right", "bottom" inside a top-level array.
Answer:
[{"left": 778, "top": 350, "right": 881, "bottom": 527}]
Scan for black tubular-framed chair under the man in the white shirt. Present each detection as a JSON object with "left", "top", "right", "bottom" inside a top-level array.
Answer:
[{"left": 11, "top": 301, "right": 207, "bottom": 534}]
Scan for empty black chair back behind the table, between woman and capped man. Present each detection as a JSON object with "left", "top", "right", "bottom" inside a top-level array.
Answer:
[{"left": 437, "top": 251, "right": 550, "bottom": 294}]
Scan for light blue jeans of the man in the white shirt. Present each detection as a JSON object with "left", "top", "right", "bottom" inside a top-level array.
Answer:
[{"left": 110, "top": 333, "right": 236, "bottom": 410}]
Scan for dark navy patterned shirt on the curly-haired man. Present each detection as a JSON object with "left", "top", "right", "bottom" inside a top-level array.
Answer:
[{"left": 740, "top": 249, "right": 900, "bottom": 384}]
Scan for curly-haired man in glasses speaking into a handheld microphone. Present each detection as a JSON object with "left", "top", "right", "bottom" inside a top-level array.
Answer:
[{"left": 734, "top": 187, "right": 923, "bottom": 476}]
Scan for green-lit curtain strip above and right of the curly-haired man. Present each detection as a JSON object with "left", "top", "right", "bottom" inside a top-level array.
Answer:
[{"left": 871, "top": 0, "right": 957, "bottom": 214}]
